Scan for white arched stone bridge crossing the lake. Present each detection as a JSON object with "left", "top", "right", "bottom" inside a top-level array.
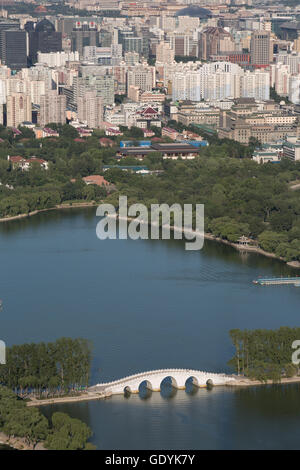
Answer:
[{"left": 89, "top": 369, "right": 236, "bottom": 395}]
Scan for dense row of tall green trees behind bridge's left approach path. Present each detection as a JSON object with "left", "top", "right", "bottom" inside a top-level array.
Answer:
[{"left": 0, "top": 338, "right": 91, "bottom": 397}]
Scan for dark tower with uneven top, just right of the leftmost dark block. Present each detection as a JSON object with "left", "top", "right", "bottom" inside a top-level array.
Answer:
[{"left": 25, "top": 19, "right": 62, "bottom": 63}]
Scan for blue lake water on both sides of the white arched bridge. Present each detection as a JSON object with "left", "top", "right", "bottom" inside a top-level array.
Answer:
[{"left": 0, "top": 209, "right": 300, "bottom": 449}]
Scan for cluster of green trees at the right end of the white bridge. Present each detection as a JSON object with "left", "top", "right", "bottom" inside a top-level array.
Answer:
[{"left": 228, "top": 327, "right": 300, "bottom": 382}]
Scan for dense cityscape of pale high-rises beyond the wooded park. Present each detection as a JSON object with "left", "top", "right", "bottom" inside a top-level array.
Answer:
[{"left": 0, "top": 0, "right": 300, "bottom": 162}]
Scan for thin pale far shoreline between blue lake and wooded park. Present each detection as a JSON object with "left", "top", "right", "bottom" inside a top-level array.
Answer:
[{"left": 0, "top": 201, "right": 300, "bottom": 269}]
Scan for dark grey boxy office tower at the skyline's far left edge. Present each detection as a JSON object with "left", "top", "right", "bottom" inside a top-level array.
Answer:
[{"left": 0, "top": 29, "right": 27, "bottom": 70}]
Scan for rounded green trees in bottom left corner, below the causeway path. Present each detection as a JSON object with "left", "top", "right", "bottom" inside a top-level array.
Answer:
[{"left": 0, "top": 386, "right": 94, "bottom": 450}]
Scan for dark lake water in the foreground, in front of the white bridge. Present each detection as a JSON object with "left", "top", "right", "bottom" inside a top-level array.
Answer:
[{"left": 43, "top": 385, "right": 300, "bottom": 450}]
